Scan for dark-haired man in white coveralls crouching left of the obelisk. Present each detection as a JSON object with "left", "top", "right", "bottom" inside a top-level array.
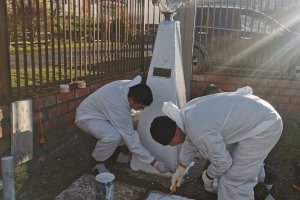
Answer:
[{"left": 75, "top": 76, "right": 169, "bottom": 173}]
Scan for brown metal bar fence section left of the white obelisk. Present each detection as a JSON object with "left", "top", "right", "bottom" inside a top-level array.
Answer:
[{"left": 0, "top": 0, "right": 160, "bottom": 101}]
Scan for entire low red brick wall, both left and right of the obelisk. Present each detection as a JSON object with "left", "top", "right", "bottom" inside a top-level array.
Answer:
[{"left": 0, "top": 74, "right": 300, "bottom": 156}]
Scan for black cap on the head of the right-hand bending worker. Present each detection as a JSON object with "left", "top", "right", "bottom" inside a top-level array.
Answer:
[{"left": 150, "top": 116, "right": 177, "bottom": 146}]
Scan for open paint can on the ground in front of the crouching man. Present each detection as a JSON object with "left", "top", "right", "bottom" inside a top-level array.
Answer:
[{"left": 95, "top": 172, "right": 115, "bottom": 200}]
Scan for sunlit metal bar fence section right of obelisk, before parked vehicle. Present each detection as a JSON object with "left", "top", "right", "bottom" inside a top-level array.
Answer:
[{"left": 193, "top": 0, "right": 300, "bottom": 79}]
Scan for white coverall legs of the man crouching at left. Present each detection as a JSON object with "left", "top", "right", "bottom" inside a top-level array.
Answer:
[{"left": 76, "top": 119, "right": 123, "bottom": 161}]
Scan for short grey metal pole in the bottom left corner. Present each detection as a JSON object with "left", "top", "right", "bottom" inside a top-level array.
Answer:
[{"left": 1, "top": 156, "right": 16, "bottom": 200}]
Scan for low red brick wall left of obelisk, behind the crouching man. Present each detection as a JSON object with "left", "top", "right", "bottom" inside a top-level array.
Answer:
[{"left": 0, "top": 73, "right": 134, "bottom": 156}]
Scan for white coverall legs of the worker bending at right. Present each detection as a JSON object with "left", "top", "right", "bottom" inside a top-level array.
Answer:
[{"left": 218, "top": 120, "right": 282, "bottom": 200}]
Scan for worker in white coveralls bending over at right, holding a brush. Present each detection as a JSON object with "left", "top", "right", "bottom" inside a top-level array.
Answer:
[{"left": 150, "top": 87, "right": 283, "bottom": 200}]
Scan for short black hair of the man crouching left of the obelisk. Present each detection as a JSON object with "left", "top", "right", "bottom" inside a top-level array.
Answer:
[{"left": 128, "top": 83, "right": 153, "bottom": 106}]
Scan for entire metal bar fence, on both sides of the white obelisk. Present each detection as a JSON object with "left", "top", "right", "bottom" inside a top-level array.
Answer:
[{"left": 0, "top": 0, "right": 300, "bottom": 104}]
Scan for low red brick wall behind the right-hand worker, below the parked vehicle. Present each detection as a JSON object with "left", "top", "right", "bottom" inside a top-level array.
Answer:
[{"left": 191, "top": 74, "right": 300, "bottom": 122}]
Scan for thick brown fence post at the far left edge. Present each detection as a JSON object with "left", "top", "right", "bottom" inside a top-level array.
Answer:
[{"left": 0, "top": 1, "right": 11, "bottom": 104}]
